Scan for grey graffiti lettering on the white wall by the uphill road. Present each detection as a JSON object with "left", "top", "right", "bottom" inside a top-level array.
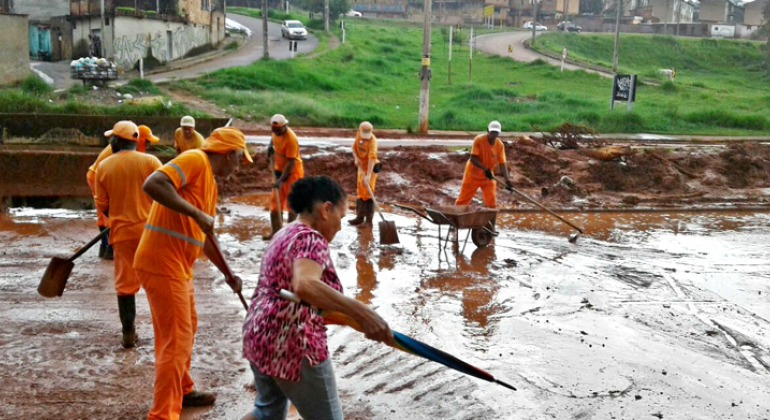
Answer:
[{"left": 113, "top": 25, "right": 208, "bottom": 68}]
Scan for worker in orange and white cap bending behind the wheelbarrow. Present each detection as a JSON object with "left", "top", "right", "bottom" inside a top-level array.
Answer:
[{"left": 455, "top": 121, "right": 513, "bottom": 208}]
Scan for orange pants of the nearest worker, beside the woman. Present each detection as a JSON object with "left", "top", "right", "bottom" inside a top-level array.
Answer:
[{"left": 136, "top": 271, "right": 198, "bottom": 420}]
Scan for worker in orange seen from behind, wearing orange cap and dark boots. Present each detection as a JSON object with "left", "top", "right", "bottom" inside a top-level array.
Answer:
[{"left": 94, "top": 121, "right": 161, "bottom": 349}]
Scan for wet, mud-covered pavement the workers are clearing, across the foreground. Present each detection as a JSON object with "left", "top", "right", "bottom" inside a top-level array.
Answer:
[{"left": 0, "top": 195, "right": 770, "bottom": 419}]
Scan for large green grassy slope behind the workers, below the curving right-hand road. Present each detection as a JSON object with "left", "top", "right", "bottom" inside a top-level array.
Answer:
[{"left": 170, "top": 13, "right": 770, "bottom": 135}]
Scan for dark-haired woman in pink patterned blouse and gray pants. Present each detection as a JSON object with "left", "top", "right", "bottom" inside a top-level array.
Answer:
[{"left": 243, "top": 176, "right": 393, "bottom": 420}]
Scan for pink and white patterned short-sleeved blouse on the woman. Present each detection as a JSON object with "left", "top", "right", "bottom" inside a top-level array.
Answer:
[{"left": 243, "top": 222, "right": 342, "bottom": 381}]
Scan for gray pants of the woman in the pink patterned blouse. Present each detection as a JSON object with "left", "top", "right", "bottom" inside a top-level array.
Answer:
[{"left": 251, "top": 358, "right": 343, "bottom": 420}]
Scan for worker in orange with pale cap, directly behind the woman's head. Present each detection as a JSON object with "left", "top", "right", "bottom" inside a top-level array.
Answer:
[{"left": 264, "top": 114, "right": 305, "bottom": 241}]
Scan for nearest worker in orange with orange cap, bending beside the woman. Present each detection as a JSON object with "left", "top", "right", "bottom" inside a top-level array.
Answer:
[{"left": 134, "top": 127, "right": 252, "bottom": 420}]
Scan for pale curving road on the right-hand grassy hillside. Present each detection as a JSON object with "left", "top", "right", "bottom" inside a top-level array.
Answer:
[{"left": 476, "top": 31, "right": 612, "bottom": 78}]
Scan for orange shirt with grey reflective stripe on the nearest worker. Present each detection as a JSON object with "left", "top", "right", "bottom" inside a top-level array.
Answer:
[{"left": 134, "top": 150, "right": 217, "bottom": 279}]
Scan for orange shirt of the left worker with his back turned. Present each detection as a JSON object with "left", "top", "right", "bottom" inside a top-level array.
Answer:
[{"left": 94, "top": 150, "right": 161, "bottom": 244}]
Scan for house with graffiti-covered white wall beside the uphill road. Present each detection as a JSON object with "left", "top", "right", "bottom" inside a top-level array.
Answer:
[{"left": 69, "top": 0, "right": 225, "bottom": 69}]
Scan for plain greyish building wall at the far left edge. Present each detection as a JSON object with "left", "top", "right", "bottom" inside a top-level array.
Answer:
[{"left": 0, "top": 12, "right": 29, "bottom": 85}]
